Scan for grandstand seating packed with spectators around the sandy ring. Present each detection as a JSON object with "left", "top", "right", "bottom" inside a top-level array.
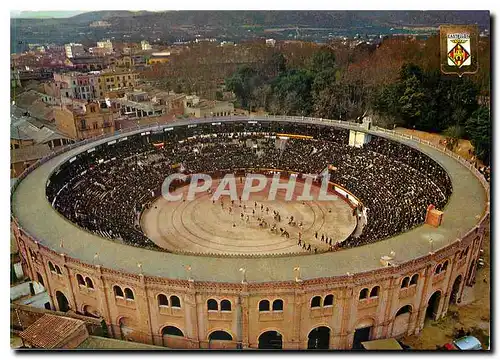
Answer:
[{"left": 47, "top": 122, "right": 452, "bottom": 250}]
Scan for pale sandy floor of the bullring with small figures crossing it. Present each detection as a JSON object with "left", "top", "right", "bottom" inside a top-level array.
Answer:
[{"left": 141, "top": 181, "right": 356, "bottom": 255}]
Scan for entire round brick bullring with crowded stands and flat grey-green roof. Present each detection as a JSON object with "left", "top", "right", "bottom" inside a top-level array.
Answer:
[{"left": 12, "top": 117, "right": 489, "bottom": 349}]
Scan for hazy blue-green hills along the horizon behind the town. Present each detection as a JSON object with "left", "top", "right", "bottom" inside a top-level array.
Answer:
[{"left": 11, "top": 10, "right": 490, "bottom": 52}]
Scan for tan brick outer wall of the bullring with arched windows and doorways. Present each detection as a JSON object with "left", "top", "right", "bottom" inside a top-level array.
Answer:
[{"left": 12, "top": 117, "right": 489, "bottom": 349}]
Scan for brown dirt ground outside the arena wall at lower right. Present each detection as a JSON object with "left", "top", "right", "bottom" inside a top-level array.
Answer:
[{"left": 402, "top": 219, "right": 491, "bottom": 350}]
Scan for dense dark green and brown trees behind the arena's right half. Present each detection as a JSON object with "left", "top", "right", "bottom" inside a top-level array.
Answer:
[{"left": 225, "top": 43, "right": 491, "bottom": 163}]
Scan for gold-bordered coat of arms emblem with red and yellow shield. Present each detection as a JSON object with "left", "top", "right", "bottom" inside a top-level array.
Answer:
[{"left": 440, "top": 25, "right": 478, "bottom": 76}]
